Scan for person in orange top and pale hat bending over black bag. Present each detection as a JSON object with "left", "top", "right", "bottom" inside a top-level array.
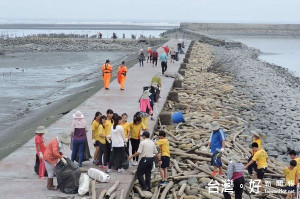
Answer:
[{"left": 44, "top": 132, "right": 71, "bottom": 190}]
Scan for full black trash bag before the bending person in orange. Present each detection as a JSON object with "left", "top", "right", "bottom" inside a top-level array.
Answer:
[{"left": 56, "top": 158, "right": 81, "bottom": 194}]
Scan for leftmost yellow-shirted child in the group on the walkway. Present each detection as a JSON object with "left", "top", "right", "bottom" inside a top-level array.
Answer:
[{"left": 92, "top": 111, "right": 102, "bottom": 165}]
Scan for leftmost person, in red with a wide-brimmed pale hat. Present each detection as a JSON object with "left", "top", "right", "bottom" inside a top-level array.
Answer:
[{"left": 34, "top": 126, "right": 48, "bottom": 178}]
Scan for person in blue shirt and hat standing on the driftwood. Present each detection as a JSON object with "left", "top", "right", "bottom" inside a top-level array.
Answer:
[{"left": 208, "top": 121, "right": 225, "bottom": 177}]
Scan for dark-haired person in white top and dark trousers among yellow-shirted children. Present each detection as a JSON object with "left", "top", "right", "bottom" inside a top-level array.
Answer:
[{"left": 107, "top": 116, "right": 125, "bottom": 173}]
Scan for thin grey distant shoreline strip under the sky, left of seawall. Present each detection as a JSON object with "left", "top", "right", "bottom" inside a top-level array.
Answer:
[{"left": 0, "top": 24, "right": 179, "bottom": 30}]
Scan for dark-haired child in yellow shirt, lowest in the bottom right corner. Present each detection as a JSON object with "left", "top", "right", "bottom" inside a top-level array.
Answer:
[{"left": 283, "top": 160, "right": 298, "bottom": 199}]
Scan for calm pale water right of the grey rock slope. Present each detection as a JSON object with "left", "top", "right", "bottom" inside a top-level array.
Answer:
[{"left": 226, "top": 36, "right": 300, "bottom": 76}]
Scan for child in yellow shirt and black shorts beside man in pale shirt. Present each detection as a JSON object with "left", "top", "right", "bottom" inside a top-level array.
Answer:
[{"left": 156, "top": 131, "right": 170, "bottom": 185}]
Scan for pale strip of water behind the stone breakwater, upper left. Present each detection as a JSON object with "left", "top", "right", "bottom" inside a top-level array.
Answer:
[{"left": 0, "top": 29, "right": 165, "bottom": 38}]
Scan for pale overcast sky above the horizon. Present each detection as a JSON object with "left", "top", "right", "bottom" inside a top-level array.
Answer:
[{"left": 0, "top": 0, "right": 300, "bottom": 23}]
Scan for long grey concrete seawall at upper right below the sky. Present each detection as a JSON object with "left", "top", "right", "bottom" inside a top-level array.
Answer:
[{"left": 180, "top": 23, "right": 300, "bottom": 36}]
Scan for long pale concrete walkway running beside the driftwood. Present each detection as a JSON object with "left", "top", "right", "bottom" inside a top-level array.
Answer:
[{"left": 0, "top": 39, "right": 190, "bottom": 199}]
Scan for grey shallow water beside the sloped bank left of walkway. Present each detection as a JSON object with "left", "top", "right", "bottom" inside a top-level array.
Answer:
[{"left": 0, "top": 52, "right": 128, "bottom": 131}]
